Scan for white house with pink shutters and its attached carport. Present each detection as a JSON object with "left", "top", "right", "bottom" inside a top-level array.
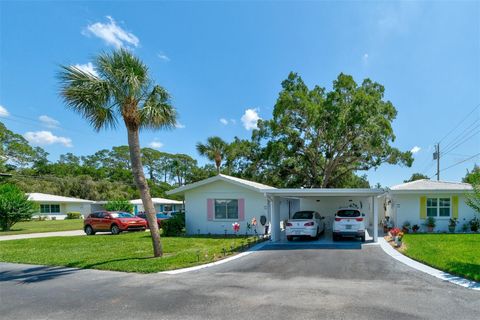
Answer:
[{"left": 167, "top": 174, "right": 385, "bottom": 241}]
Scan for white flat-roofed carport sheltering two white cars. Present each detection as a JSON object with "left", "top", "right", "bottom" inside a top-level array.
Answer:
[{"left": 264, "top": 188, "right": 385, "bottom": 242}]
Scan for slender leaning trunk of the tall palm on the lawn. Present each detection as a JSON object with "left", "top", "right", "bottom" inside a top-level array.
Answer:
[{"left": 127, "top": 127, "right": 163, "bottom": 257}]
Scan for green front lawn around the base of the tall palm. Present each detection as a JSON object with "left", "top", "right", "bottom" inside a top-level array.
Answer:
[{"left": 0, "top": 232, "right": 253, "bottom": 273}]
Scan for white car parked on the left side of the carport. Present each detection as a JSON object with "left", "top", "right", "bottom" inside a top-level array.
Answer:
[{"left": 285, "top": 211, "right": 325, "bottom": 241}]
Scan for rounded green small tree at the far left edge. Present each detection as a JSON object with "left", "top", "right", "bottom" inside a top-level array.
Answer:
[{"left": 0, "top": 183, "right": 36, "bottom": 231}]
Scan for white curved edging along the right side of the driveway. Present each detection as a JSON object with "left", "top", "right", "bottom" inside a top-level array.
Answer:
[{"left": 378, "top": 237, "right": 480, "bottom": 291}]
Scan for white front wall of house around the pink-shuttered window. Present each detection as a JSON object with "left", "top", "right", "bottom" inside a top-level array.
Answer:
[{"left": 185, "top": 181, "right": 270, "bottom": 235}]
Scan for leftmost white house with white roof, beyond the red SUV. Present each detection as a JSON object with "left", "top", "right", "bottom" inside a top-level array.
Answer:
[{"left": 27, "top": 193, "right": 94, "bottom": 220}]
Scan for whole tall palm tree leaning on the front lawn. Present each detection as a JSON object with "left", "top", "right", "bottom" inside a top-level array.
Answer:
[{"left": 59, "top": 49, "right": 176, "bottom": 257}]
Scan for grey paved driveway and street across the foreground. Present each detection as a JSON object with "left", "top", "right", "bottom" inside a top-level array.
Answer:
[{"left": 0, "top": 245, "right": 480, "bottom": 319}]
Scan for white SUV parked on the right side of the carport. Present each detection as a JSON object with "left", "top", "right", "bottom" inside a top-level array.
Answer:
[{"left": 333, "top": 208, "right": 365, "bottom": 242}]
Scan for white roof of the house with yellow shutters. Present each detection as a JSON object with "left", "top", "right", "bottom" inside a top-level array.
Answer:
[{"left": 390, "top": 179, "right": 472, "bottom": 193}]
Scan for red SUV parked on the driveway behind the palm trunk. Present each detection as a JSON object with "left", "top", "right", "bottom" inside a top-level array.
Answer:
[{"left": 83, "top": 211, "right": 147, "bottom": 236}]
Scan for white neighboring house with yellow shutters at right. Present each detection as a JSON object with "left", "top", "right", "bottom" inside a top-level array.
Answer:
[{"left": 386, "top": 179, "right": 475, "bottom": 231}]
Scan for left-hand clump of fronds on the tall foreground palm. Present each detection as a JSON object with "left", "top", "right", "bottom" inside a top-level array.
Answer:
[{"left": 58, "top": 66, "right": 117, "bottom": 131}]
